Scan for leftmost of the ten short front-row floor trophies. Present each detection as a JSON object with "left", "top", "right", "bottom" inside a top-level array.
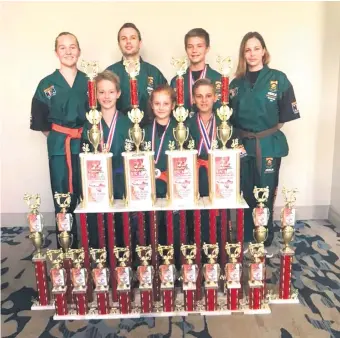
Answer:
[{"left": 46, "top": 249, "right": 68, "bottom": 316}]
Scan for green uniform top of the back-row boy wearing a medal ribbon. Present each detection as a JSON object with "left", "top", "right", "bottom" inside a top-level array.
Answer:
[{"left": 171, "top": 64, "right": 221, "bottom": 118}]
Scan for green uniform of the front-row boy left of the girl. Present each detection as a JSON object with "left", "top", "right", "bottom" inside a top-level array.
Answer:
[{"left": 82, "top": 111, "right": 132, "bottom": 248}]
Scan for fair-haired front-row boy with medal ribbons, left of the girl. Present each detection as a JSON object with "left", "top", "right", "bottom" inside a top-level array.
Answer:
[{"left": 83, "top": 70, "right": 131, "bottom": 248}]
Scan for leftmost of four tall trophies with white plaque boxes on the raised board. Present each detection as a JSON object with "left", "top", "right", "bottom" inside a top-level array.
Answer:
[{"left": 79, "top": 61, "right": 115, "bottom": 210}]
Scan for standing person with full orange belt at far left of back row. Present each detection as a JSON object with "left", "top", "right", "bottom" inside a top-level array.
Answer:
[{"left": 30, "top": 32, "right": 87, "bottom": 248}]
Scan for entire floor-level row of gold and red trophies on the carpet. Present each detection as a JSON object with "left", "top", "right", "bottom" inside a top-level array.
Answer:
[{"left": 25, "top": 187, "right": 297, "bottom": 318}]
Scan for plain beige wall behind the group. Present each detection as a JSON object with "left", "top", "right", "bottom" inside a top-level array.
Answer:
[{"left": 0, "top": 2, "right": 340, "bottom": 224}]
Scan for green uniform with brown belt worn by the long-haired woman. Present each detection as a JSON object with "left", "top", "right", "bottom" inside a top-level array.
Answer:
[{"left": 230, "top": 65, "right": 300, "bottom": 245}]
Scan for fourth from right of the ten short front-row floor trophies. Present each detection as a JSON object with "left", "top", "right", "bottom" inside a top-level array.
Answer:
[{"left": 181, "top": 244, "right": 199, "bottom": 311}]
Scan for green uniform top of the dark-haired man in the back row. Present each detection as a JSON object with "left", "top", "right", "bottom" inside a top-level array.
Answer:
[{"left": 107, "top": 58, "right": 167, "bottom": 126}]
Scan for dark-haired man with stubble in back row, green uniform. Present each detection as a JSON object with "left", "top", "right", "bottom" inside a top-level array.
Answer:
[{"left": 107, "top": 23, "right": 167, "bottom": 125}]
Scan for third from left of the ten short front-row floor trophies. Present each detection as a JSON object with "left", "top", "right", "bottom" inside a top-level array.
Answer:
[{"left": 90, "top": 248, "right": 110, "bottom": 315}]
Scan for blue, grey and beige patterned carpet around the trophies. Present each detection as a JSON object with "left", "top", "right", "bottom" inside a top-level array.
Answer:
[{"left": 1, "top": 221, "right": 340, "bottom": 338}]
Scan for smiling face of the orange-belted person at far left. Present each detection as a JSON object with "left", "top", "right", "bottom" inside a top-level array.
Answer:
[{"left": 55, "top": 34, "right": 80, "bottom": 67}]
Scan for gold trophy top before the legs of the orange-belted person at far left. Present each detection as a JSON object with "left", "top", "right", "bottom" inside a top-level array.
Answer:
[{"left": 54, "top": 192, "right": 73, "bottom": 253}]
